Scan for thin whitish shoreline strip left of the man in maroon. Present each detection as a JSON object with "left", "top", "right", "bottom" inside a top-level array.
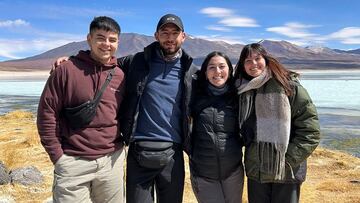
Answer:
[{"left": 0, "top": 70, "right": 49, "bottom": 80}]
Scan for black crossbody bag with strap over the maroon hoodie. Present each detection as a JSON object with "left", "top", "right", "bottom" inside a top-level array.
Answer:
[{"left": 63, "top": 68, "right": 115, "bottom": 129}]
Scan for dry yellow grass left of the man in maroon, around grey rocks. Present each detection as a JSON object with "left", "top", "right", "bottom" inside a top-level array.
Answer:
[{"left": 0, "top": 111, "right": 53, "bottom": 202}]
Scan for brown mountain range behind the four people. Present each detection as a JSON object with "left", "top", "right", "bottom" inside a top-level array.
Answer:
[{"left": 0, "top": 33, "right": 360, "bottom": 71}]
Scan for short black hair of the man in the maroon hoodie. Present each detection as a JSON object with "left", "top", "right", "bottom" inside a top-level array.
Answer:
[{"left": 90, "top": 16, "right": 121, "bottom": 35}]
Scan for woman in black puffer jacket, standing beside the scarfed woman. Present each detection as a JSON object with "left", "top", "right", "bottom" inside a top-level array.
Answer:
[{"left": 190, "top": 52, "right": 244, "bottom": 203}]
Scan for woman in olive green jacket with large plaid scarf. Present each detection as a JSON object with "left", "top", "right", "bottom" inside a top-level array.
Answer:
[{"left": 235, "top": 43, "right": 320, "bottom": 203}]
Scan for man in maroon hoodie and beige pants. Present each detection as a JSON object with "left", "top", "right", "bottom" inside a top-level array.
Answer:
[{"left": 37, "top": 16, "right": 125, "bottom": 203}]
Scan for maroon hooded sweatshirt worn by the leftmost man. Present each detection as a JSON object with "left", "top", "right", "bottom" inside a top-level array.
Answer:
[{"left": 37, "top": 51, "right": 125, "bottom": 163}]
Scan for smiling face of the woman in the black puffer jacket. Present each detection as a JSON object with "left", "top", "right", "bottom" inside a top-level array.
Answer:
[{"left": 206, "top": 56, "right": 229, "bottom": 87}]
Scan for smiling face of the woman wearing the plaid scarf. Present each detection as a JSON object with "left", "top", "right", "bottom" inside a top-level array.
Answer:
[{"left": 244, "top": 52, "right": 266, "bottom": 78}]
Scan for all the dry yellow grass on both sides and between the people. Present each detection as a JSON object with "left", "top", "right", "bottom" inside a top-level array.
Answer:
[{"left": 0, "top": 111, "right": 360, "bottom": 203}]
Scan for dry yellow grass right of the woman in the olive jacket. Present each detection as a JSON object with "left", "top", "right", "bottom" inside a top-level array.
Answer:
[{"left": 301, "top": 149, "right": 360, "bottom": 203}]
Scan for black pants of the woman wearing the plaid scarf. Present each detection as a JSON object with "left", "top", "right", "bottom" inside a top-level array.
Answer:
[{"left": 248, "top": 179, "right": 301, "bottom": 203}]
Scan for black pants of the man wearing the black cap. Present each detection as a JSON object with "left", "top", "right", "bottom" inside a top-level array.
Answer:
[{"left": 126, "top": 144, "right": 185, "bottom": 203}]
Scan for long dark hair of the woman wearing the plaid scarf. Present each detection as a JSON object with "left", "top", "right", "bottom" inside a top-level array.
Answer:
[{"left": 235, "top": 43, "right": 299, "bottom": 96}]
